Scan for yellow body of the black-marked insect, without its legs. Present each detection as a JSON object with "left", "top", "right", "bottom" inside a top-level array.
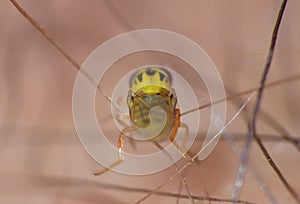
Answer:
[{"left": 127, "top": 67, "right": 177, "bottom": 140}]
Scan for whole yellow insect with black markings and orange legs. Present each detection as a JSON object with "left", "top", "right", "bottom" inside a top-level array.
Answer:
[{"left": 94, "top": 66, "right": 190, "bottom": 176}]
